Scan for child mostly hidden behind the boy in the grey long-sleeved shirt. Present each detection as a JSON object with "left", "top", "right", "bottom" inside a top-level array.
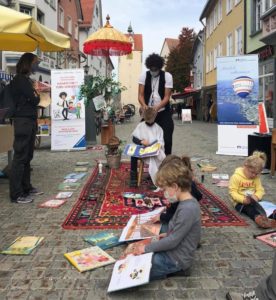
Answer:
[{"left": 151, "top": 155, "right": 202, "bottom": 232}]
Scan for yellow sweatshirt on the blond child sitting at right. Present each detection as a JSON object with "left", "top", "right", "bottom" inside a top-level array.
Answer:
[{"left": 229, "top": 167, "right": 265, "bottom": 206}]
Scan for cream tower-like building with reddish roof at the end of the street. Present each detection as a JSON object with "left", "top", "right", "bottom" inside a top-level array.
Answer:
[{"left": 118, "top": 26, "right": 143, "bottom": 107}]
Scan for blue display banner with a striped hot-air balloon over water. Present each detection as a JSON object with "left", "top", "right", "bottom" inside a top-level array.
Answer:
[{"left": 217, "top": 55, "right": 259, "bottom": 156}]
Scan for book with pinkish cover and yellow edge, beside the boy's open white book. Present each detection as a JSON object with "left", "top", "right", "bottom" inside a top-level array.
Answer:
[{"left": 64, "top": 246, "right": 115, "bottom": 272}]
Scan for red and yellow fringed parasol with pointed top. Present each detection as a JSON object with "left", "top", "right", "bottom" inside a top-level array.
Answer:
[{"left": 83, "top": 15, "right": 132, "bottom": 56}]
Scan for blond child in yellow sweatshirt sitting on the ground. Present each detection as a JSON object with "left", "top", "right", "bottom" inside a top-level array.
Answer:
[{"left": 229, "top": 151, "right": 276, "bottom": 228}]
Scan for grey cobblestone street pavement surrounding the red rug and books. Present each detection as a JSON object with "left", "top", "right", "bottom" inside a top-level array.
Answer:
[{"left": 0, "top": 117, "right": 276, "bottom": 300}]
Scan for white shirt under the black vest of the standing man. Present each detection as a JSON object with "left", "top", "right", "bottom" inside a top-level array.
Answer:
[{"left": 139, "top": 72, "right": 173, "bottom": 111}]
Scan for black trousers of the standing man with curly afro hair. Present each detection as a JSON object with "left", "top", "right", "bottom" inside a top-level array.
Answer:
[{"left": 155, "top": 110, "right": 174, "bottom": 155}]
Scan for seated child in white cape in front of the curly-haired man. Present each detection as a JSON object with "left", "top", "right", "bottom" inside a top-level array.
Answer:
[{"left": 130, "top": 107, "right": 166, "bottom": 187}]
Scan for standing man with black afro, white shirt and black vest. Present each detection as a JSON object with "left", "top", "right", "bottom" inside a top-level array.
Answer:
[{"left": 138, "top": 53, "right": 174, "bottom": 155}]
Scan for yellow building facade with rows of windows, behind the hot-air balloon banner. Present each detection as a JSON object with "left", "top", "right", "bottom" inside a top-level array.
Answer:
[{"left": 200, "top": 0, "right": 244, "bottom": 119}]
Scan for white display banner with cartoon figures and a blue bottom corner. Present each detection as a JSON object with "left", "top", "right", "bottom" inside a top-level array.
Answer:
[{"left": 51, "top": 69, "right": 86, "bottom": 150}]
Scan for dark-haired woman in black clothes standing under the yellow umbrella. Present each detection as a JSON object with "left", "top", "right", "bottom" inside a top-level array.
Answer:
[{"left": 10, "top": 53, "right": 40, "bottom": 203}]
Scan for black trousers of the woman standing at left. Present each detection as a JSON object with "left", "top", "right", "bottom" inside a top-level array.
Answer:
[{"left": 10, "top": 118, "right": 37, "bottom": 201}]
